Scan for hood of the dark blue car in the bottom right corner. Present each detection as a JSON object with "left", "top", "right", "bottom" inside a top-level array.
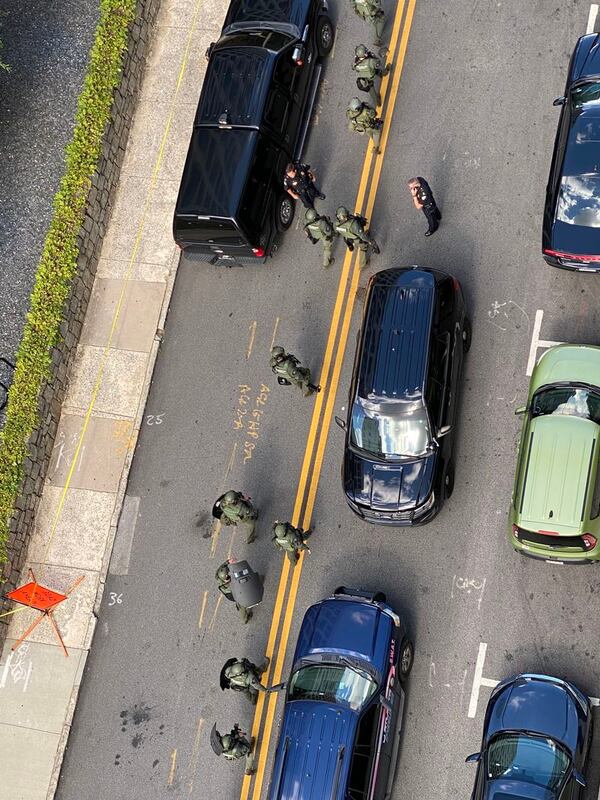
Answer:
[{"left": 485, "top": 678, "right": 579, "bottom": 754}]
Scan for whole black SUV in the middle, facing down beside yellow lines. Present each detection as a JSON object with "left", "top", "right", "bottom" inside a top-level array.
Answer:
[{"left": 336, "top": 267, "right": 471, "bottom": 526}]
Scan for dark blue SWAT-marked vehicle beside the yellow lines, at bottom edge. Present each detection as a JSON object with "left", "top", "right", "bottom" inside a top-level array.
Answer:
[{"left": 269, "top": 587, "right": 414, "bottom": 800}]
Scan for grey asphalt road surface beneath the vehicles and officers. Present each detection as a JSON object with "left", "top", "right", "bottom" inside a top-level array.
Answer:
[{"left": 57, "top": 0, "right": 600, "bottom": 800}]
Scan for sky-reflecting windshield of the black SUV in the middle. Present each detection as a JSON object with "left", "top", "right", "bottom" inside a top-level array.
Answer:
[{"left": 350, "top": 401, "right": 431, "bottom": 458}]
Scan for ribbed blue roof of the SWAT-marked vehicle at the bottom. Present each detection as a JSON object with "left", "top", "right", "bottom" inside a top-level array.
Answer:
[{"left": 269, "top": 700, "right": 359, "bottom": 800}]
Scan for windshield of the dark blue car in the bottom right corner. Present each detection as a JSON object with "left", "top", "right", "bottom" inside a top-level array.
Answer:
[{"left": 487, "top": 733, "right": 570, "bottom": 792}]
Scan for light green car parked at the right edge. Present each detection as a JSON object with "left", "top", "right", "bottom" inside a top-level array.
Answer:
[{"left": 509, "top": 344, "right": 600, "bottom": 564}]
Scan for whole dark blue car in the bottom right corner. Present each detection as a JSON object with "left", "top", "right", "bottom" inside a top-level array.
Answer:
[{"left": 467, "top": 675, "right": 592, "bottom": 800}]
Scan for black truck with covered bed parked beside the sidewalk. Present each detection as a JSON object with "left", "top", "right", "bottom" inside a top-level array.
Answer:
[{"left": 173, "top": 0, "right": 333, "bottom": 264}]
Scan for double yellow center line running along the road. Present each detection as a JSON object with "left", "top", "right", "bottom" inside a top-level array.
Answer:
[{"left": 245, "top": 0, "right": 416, "bottom": 800}]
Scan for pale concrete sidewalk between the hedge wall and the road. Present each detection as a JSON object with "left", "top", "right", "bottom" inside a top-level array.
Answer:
[{"left": 0, "top": 0, "right": 226, "bottom": 800}]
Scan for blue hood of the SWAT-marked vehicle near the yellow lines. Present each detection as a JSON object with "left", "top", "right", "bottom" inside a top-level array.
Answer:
[{"left": 294, "top": 598, "right": 393, "bottom": 675}]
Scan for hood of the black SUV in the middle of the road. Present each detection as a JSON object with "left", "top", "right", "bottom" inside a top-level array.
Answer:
[{"left": 344, "top": 448, "right": 436, "bottom": 511}]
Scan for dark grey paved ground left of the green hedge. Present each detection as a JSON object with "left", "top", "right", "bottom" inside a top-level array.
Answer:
[{"left": 0, "top": 0, "right": 99, "bottom": 359}]
